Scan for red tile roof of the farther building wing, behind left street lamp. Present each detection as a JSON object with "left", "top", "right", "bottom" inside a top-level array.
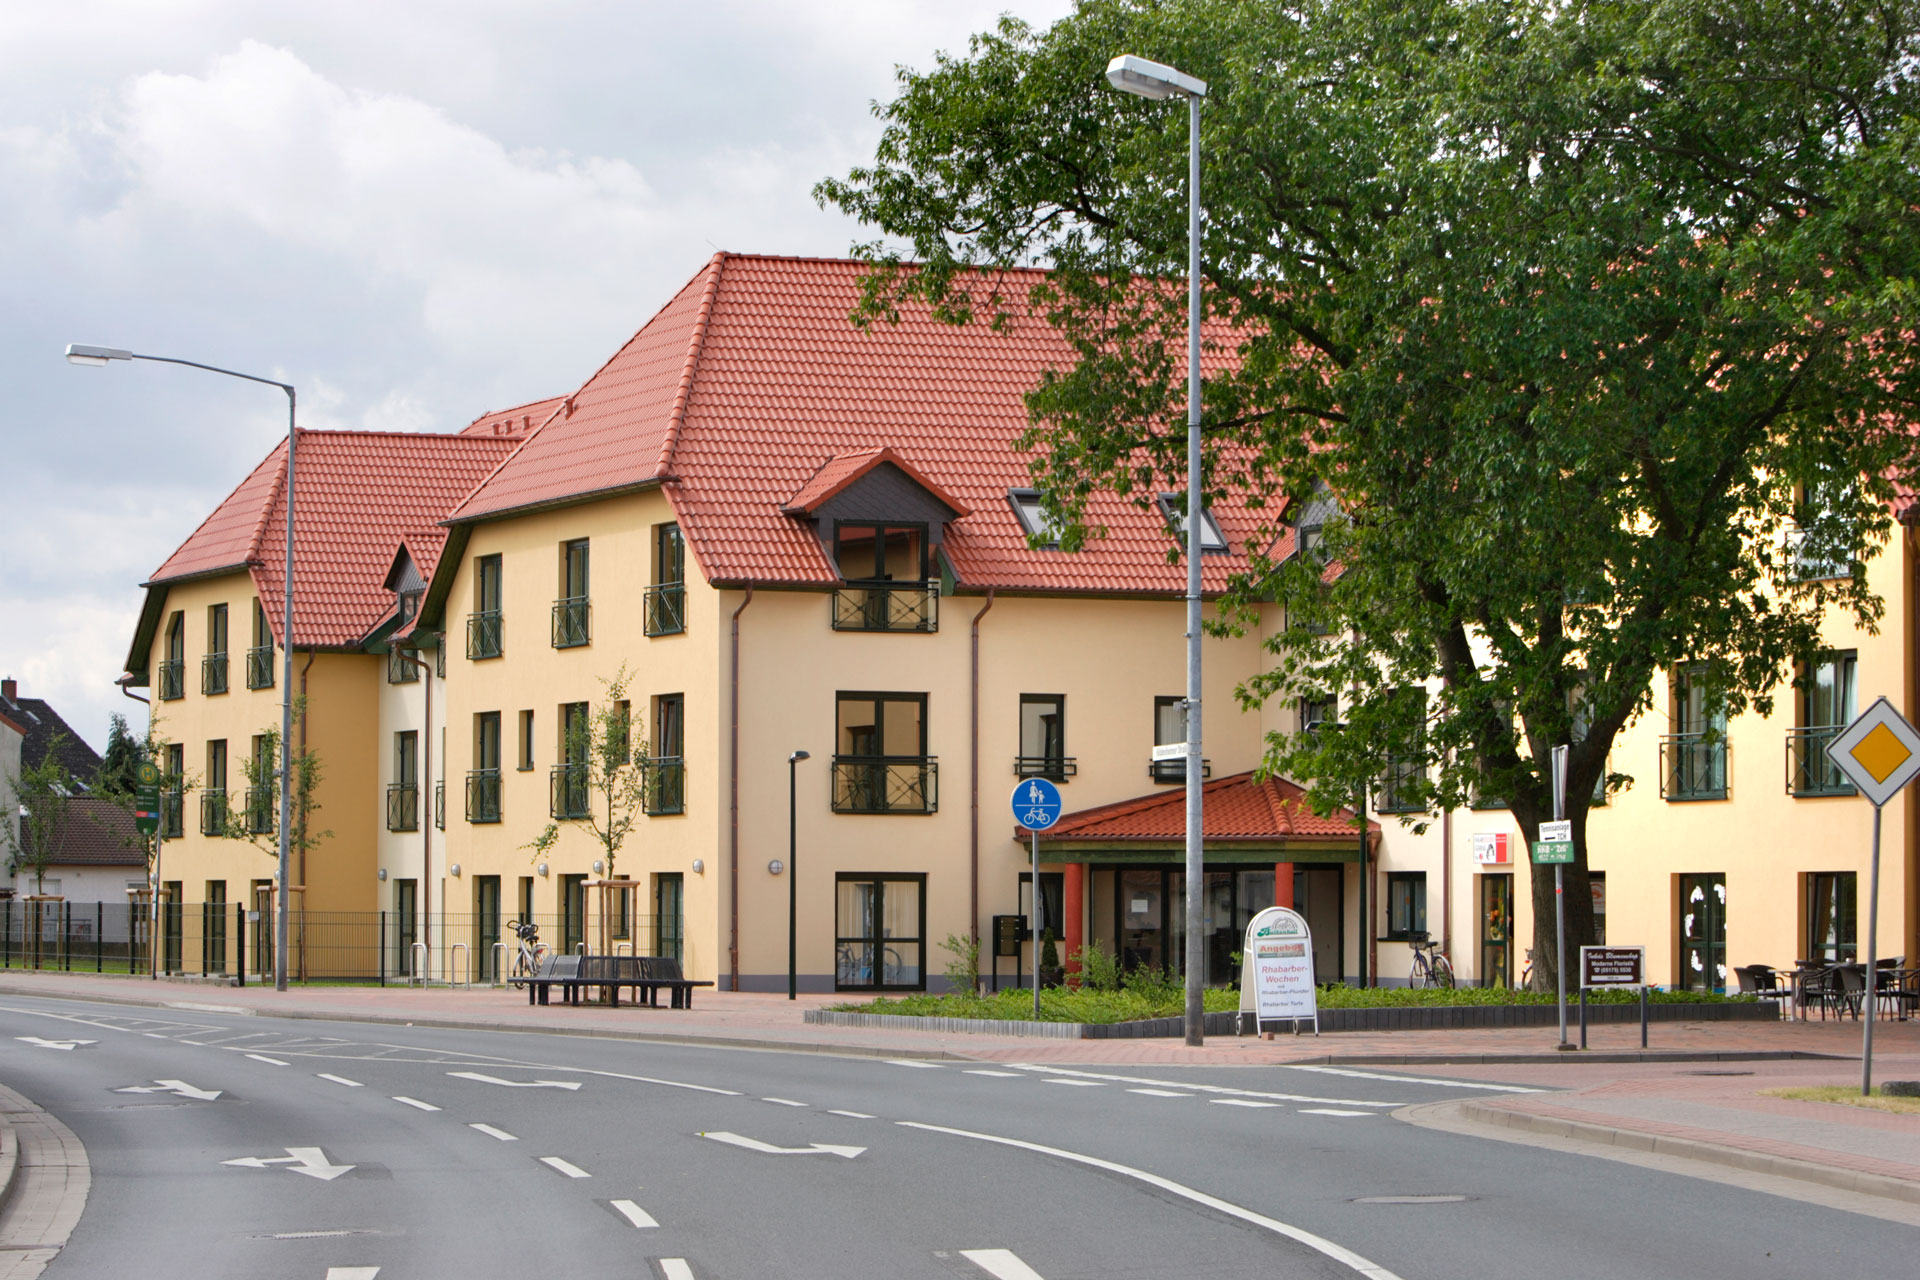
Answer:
[{"left": 148, "top": 430, "right": 518, "bottom": 647}]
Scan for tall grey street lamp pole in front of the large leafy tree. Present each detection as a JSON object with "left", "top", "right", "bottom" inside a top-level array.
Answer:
[{"left": 1105, "top": 54, "right": 1206, "bottom": 1044}]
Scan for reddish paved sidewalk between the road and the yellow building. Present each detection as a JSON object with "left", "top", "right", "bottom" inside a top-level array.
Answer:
[{"left": 0, "top": 971, "right": 1920, "bottom": 1205}]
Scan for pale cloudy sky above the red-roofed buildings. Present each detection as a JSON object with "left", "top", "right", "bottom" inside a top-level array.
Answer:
[{"left": 0, "top": 0, "right": 1069, "bottom": 747}]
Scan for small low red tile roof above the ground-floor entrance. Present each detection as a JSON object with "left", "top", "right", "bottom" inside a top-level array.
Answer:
[{"left": 1036, "top": 771, "right": 1380, "bottom": 844}]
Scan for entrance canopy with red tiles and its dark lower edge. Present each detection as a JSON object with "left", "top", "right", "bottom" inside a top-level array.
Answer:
[{"left": 1016, "top": 771, "right": 1380, "bottom": 864}]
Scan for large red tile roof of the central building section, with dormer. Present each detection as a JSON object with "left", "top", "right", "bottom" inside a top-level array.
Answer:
[{"left": 451, "top": 253, "right": 1273, "bottom": 595}]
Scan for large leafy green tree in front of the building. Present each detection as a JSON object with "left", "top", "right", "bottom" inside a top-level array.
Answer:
[{"left": 818, "top": 0, "right": 1920, "bottom": 984}]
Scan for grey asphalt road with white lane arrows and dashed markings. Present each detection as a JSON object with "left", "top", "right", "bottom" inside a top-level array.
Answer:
[{"left": 0, "top": 998, "right": 1920, "bottom": 1280}]
